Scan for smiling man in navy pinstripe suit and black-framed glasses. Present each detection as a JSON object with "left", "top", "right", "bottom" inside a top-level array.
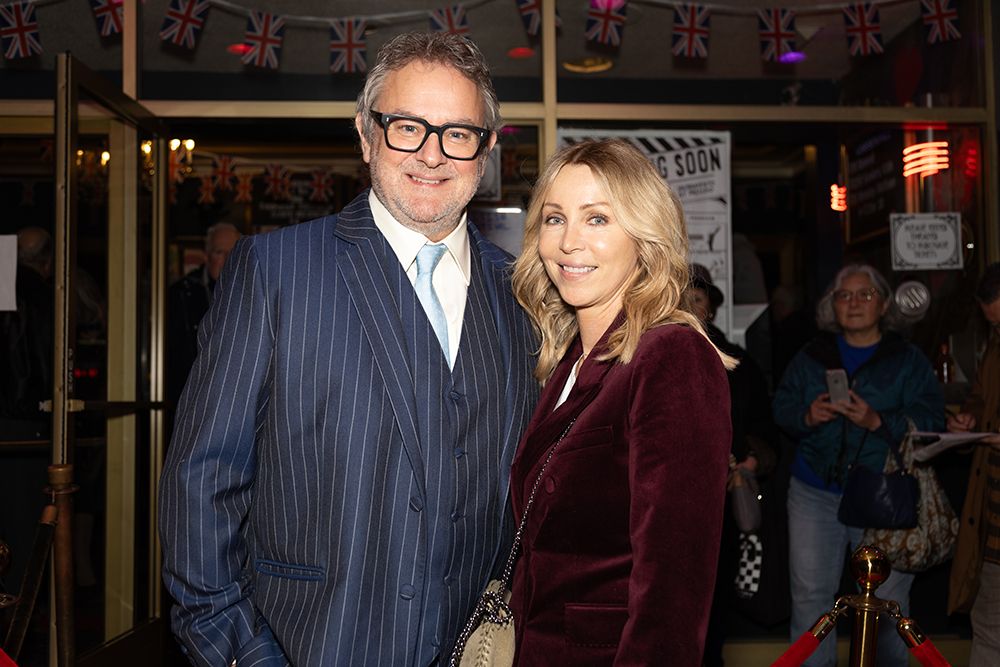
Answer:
[{"left": 160, "top": 33, "right": 537, "bottom": 667}]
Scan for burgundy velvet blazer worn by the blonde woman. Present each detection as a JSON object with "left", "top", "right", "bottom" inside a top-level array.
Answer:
[{"left": 511, "top": 318, "right": 731, "bottom": 667}]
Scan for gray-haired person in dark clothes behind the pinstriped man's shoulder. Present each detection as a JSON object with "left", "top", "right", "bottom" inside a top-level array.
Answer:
[{"left": 167, "top": 222, "right": 243, "bottom": 405}]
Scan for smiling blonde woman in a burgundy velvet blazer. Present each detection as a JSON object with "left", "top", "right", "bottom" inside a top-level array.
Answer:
[{"left": 511, "top": 140, "right": 732, "bottom": 667}]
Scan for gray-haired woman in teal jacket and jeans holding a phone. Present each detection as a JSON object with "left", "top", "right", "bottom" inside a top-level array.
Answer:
[{"left": 774, "top": 264, "right": 944, "bottom": 667}]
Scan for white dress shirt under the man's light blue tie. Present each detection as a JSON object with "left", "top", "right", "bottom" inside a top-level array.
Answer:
[{"left": 368, "top": 190, "right": 472, "bottom": 367}]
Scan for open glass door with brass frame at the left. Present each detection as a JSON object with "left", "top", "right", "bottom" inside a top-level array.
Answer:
[{"left": 49, "top": 54, "right": 168, "bottom": 665}]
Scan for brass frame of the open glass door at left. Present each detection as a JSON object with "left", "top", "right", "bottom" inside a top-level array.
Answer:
[{"left": 51, "top": 53, "right": 167, "bottom": 664}]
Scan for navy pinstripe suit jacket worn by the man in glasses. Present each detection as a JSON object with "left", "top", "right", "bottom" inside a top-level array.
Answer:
[{"left": 159, "top": 193, "right": 538, "bottom": 667}]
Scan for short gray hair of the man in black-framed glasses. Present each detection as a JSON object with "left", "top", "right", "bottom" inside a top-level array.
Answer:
[{"left": 356, "top": 32, "right": 503, "bottom": 141}]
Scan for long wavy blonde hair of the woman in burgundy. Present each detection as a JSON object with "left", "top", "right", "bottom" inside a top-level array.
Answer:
[{"left": 513, "top": 139, "right": 736, "bottom": 384}]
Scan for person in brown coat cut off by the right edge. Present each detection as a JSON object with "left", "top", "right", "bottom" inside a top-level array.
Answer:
[{"left": 948, "top": 262, "right": 1000, "bottom": 667}]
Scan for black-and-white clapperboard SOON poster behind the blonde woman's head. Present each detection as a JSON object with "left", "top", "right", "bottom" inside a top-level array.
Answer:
[{"left": 559, "top": 128, "right": 733, "bottom": 336}]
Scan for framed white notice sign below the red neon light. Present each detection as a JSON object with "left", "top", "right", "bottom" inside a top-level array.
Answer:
[{"left": 889, "top": 213, "right": 962, "bottom": 271}]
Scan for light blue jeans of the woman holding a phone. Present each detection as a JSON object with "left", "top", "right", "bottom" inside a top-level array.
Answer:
[{"left": 788, "top": 477, "right": 913, "bottom": 667}]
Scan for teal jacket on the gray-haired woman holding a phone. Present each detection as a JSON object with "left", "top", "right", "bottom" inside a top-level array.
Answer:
[{"left": 773, "top": 332, "right": 944, "bottom": 490}]
